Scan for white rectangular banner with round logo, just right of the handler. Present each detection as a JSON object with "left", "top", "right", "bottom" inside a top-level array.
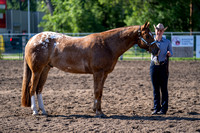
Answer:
[{"left": 171, "top": 36, "right": 194, "bottom": 47}]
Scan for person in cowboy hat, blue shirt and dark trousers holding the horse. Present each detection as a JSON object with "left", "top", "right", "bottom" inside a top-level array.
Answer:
[{"left": 150, "top": 23, "right": 173, "bottom": 115}]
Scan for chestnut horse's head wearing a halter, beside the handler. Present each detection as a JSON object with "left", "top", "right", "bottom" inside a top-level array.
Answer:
[{"left": 138, "top": 22, "right": 160, "bottom": 55}]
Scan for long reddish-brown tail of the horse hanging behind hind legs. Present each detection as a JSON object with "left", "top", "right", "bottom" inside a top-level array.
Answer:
[{"left": 21, "top": 59, "right": 32, "bottom": 107}]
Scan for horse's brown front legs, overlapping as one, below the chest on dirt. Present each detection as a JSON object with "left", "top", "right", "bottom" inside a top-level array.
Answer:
[{"left": 93, "top": 71, "right": 107, "bottom": 117}]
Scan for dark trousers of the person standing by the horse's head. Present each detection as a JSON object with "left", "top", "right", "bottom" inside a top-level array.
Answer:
[{"left": 150, "top": 62, "right": 168, "bottom": 113}]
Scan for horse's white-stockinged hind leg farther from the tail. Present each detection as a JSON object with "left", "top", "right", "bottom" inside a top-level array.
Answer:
[{"left": 36, "top": 66, "right": 50, "bottom": 115}]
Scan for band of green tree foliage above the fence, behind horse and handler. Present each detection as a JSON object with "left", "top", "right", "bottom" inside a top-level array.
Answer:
[{"left": 36, "top": 0, "right": 200, "bottom": 33}]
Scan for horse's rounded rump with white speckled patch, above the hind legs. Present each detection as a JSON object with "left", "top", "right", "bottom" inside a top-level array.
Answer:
[{"left": 25, "top": 32, "right": 71, "bottom": 68}]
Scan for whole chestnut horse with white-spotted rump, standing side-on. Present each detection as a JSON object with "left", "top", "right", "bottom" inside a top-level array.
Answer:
[{"left": 21, "top": 22, "right": 159, "bottom": 117}]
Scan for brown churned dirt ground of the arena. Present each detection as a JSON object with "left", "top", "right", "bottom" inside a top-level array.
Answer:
[{"left": 0, "top": 60, "right": 200, "bottom": 133}]
